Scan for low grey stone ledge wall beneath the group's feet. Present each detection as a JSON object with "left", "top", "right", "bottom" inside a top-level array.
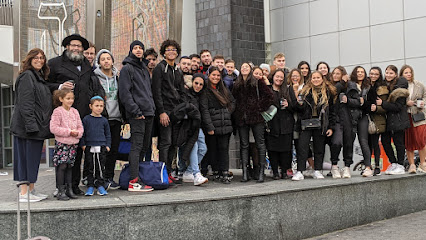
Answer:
[{"left": 0, "top": 175, "right": 426, "bottom": 240}]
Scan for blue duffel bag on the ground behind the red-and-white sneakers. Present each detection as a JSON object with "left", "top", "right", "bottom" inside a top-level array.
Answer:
[{"left": 118, "top": 161, "right": 169, "bottom": 190}]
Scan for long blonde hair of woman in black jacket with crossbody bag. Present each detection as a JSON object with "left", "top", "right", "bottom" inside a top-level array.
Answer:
[{"left": 301, "top": 71, "right": 337, "bottom": 105}]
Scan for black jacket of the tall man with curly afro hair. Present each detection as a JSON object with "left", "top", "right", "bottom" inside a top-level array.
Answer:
[{"left": 152, "top": 60, "right": 185, "bottom": 115}]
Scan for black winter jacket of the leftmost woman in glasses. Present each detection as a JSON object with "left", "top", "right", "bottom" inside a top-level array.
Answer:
[{"left": 10, "top": 70, "right": 53, "bottom": 140}]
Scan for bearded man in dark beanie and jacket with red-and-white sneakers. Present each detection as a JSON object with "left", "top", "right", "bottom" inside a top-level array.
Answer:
[{"left": 118, "top": 40, "right": 155, "bottom": 192}]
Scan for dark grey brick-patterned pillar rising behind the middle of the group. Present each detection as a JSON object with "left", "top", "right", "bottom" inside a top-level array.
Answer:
[{"left": 195, "top": 0, "right": 265, "bottom": 168}]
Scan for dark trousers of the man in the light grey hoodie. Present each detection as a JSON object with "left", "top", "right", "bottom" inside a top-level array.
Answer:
[{"left": 105, "top": 120, "right": 121, "bottom": 179}]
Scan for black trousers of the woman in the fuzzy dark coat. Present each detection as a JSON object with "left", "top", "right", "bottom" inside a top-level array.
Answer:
[{"left": 238, "top": 123, "right": 266, "bottom": 171}]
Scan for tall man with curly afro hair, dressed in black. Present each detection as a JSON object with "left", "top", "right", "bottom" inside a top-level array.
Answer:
[{"left": 152, "top": 39, "right": 184, "bottom": 183}]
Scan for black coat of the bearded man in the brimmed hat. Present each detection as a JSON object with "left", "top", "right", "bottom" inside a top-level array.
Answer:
[{"left": 47, "top": 51, "right": 99, "bottom": 119}]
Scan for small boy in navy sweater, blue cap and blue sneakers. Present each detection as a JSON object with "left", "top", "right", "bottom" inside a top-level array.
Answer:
[{"left": 81, "top": 96, "right": 111, "bottom": 196}]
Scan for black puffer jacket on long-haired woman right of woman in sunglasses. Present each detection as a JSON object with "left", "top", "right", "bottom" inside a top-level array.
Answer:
[{"left": 200, "top": 87, "right": 235, "bottom": 135}]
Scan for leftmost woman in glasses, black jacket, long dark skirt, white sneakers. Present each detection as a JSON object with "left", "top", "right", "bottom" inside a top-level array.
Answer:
[{"left": 10, "top": 48, "right": 52, "bottom": 202}]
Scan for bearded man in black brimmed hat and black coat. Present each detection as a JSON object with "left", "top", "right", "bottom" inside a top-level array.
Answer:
[{"left": 47, "top": 34, "right": 99, "bottom": 194}]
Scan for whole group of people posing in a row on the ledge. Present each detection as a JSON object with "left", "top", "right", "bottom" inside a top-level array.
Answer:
[{"left": 11, "top": 34, "right": 426, "bottom": 202}]
